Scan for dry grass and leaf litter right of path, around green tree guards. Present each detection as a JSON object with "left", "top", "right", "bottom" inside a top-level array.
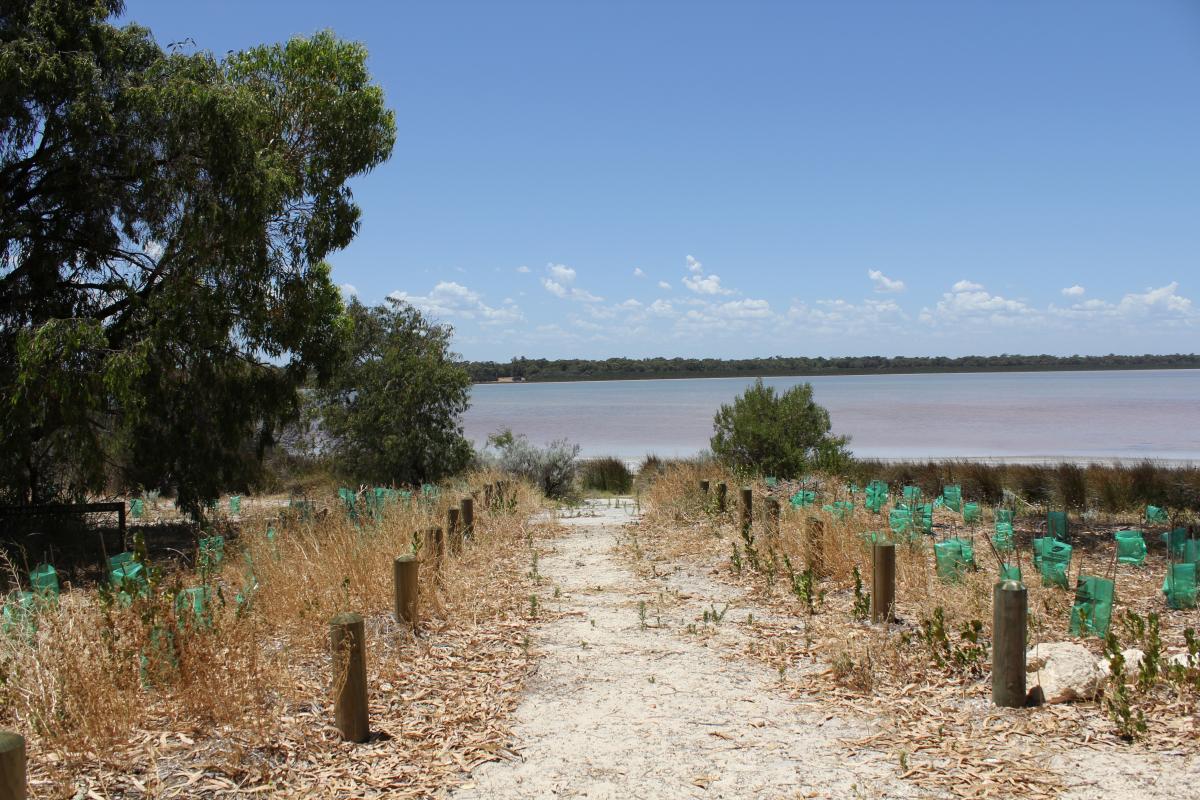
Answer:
[{"left": 626, "top": 464, "right": 1200, "bottom": 796}]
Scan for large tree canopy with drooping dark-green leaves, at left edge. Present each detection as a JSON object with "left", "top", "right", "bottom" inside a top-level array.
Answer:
[{"left": 0, "top": 0, "right": 395, "bottom": 509}]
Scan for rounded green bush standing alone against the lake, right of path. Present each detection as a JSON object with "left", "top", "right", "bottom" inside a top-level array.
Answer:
[{"left": 710, "top": 378, "right": 850, "bottom": 477}]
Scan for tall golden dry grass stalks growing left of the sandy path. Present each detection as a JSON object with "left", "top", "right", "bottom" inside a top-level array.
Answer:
[{"left": 0, "top": 471, "right": 541, "bottom": 796}]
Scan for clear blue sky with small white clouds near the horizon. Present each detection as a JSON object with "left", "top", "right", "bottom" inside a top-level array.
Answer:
[{"left": 117, "top": 0, "right": 1200, "bottom": 360}]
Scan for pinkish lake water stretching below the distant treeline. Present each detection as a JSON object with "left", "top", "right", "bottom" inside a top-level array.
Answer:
[{"left": 463, "top": 369, "right": 1200, "bottom": 461}]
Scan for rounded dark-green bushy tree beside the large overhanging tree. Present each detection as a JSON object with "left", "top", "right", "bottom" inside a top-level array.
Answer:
[{"left": 317, "top": 300, "right": 472, "bottom": 485}]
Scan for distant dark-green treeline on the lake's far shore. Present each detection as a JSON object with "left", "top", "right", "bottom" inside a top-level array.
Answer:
[{"left": 466, "top": 353, "right": 1200, "bottom": 383}]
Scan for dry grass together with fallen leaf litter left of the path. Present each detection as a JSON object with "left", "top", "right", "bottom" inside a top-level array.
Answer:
[{"left": 0, "top": 475, "right": 550, "bottom": 798}]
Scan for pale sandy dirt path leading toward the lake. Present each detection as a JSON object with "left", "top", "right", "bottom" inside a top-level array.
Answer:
[{"left": 454, "top": 507, "right": 910, "bottom": 800}]
